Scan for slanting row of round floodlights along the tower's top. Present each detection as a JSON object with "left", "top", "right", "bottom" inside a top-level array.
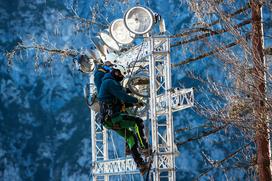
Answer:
[{"left": 77, "top": 6, "right": 165, "bottom": 73}]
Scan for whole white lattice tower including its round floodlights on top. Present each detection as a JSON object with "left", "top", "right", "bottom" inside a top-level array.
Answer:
[{"left": 86, "top": 6, "right": 194, "bottom": 181}]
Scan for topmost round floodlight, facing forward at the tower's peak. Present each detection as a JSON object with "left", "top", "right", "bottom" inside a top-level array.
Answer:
[{"left": 124, "top": 6, "right": 155, "bottom": 35}]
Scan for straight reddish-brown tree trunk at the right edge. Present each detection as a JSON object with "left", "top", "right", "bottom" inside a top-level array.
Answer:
[{"left": 251, "top": 0, "right": 271, "bottom": 181}]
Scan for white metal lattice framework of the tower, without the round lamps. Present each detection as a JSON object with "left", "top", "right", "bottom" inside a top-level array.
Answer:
[{"left": 90, "top": 36, "right": 194, "bottom": 181}]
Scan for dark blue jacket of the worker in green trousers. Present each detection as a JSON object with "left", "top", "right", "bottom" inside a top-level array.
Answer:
[{"left": 98, "top": 73, "right": 138, "bottom": 112}]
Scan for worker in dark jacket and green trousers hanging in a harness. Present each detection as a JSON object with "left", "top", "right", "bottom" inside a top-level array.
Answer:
[{"left": 98, "top": 65, "right": 151, "bottom": 175}]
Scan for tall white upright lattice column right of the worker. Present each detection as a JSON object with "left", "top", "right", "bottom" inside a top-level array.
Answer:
[{"left": 149, "top": 37, "right": 175, "bottom": 181}]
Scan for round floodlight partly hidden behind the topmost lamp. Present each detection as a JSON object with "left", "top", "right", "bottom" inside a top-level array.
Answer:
[{"left": 110, "top": 19, "right": 135, "bottom": 44}]
